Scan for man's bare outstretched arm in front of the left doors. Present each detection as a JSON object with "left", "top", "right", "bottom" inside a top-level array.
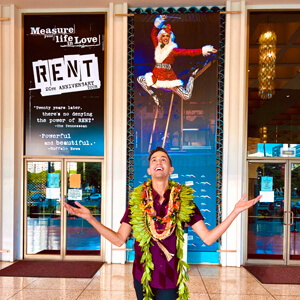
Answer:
[{"left": 64, "top": 201, "right": 131, "bottom": 247}]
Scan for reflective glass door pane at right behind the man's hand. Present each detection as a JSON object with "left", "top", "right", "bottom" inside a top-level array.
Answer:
[{"left": 248, "top": 163, "right": 285, "bottom": 259}]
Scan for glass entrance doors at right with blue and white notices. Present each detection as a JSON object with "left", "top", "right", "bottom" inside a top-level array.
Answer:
[{"left": 247, "top": 160, "right": 300, "bottom": 265}]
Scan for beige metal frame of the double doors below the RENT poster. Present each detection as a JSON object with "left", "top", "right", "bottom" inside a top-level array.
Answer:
[{"left": 22, "top": 156, "right": 105, "bottom": 261}]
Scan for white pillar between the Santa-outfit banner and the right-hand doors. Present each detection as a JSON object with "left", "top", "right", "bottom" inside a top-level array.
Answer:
[{"left": 221, "top": 1, "right": 247, "bottom": 266}]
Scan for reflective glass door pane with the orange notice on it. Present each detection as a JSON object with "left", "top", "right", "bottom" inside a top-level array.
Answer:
[{"left": 66, "top": 162, "right": 101, "bottom": 255}]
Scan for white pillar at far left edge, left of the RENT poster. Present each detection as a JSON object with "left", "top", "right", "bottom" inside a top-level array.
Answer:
[{"left": 0, "top": 5, "right": 23, "bottom": 261}]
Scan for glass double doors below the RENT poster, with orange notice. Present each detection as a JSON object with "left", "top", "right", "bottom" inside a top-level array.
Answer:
[{"left": 24, "top": 159, "right": 102, "bottom": 260}]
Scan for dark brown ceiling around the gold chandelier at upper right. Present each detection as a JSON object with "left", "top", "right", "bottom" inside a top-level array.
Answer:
[{"left": 248, "top": 11, "right": 300, "bottom": 144}]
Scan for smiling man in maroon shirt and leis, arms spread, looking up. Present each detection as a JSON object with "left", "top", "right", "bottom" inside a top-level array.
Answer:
[{"left": 64, "top": 147, "right": 261, "bottom": 300}]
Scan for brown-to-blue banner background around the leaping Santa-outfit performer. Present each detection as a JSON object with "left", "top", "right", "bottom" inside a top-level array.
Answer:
[{"left": 134, "top": 13, "right": 220, "bottom": 263}]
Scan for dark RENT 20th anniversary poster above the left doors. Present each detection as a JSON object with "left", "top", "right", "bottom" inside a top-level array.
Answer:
[{"left": 24, "top": 14, "right": 105, "bottom": 156}]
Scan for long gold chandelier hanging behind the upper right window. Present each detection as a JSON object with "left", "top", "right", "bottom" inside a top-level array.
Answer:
[{"left": 258, "top": 30, "right": 277, "bottom": 99}]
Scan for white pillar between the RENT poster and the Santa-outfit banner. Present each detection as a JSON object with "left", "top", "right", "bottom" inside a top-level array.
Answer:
[{"left": 112, "top": 3, "right": 128, "bottom": 263}]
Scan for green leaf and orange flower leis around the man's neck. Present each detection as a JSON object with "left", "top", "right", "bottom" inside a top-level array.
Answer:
[{"left": 129, "top": 180, "right": 195, "bottom": 300}]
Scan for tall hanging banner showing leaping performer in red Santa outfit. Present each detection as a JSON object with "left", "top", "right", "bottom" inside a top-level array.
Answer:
[{"left": 134, "top": 13, "right": 220, "bottom": 262}]
